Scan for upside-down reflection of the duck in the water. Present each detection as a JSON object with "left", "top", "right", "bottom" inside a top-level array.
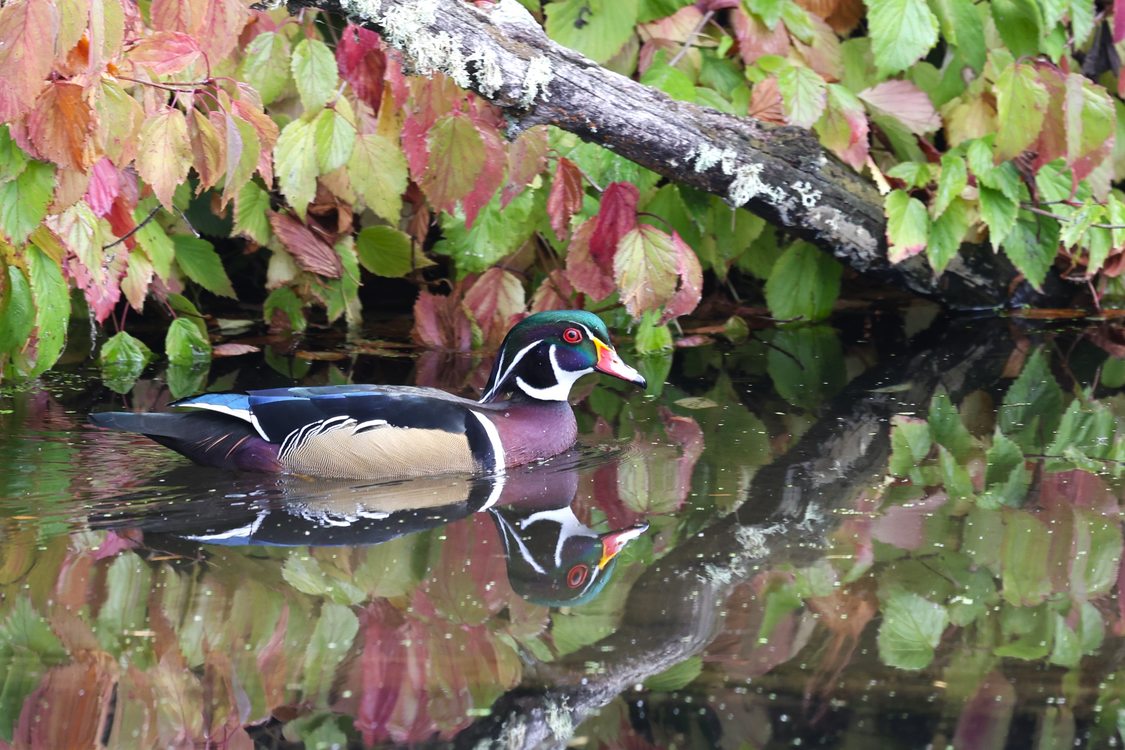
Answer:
[{"left": 90, "top": 452, "right": 648, "bottom": 606}]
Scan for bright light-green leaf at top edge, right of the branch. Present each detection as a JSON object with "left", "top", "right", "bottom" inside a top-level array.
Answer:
[{"left": 865, "top": 0, "right": 937, "bottom": 78}]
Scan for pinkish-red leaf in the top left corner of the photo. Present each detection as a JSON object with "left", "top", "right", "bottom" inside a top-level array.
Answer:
[{"left": 0, "top": 0, "right": 59, "bottom": 121}]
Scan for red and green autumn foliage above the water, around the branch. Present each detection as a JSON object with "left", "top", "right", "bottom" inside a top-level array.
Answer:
[{"left": 0, "top": 0, "right": 1125, "bottom": 377}]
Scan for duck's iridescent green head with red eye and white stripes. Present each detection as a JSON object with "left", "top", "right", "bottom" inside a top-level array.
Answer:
[{"left": 480, "top": 310, "right": 647, "bottom": 401}]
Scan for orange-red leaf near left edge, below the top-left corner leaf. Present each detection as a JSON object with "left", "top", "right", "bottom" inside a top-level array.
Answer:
[{"left": 27, "top": 81, "right": 93, "bottom": 172}]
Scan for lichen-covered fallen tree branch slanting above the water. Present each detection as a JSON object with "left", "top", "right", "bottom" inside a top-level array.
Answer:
[{"left": 288, "top": 0, "right": 1066, "bottom": 308}]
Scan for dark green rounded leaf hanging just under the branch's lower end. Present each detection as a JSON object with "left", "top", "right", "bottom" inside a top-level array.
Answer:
[{"left": 766, "top": 241, "right": 843, "bottom": 320}]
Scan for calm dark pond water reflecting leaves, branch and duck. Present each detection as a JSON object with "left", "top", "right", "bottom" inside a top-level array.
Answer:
[{"left": 0, "top": 315, "right": 1125, "bottom": 750}]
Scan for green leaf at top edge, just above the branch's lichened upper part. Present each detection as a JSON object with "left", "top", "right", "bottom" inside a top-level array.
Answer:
[{"left": 547, "top": 0, "right": 638, "bottom": 64}]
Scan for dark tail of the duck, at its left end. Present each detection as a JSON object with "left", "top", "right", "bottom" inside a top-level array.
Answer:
[{"left": 89, "top": 412, "right": 280, "bottom": 471}]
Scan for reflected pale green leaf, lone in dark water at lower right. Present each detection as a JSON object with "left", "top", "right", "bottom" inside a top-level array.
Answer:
[{"left": 878, "top": 590, "right": 950, "bottom": 670}]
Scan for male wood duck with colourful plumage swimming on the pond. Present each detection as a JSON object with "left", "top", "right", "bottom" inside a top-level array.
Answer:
[{"left": 90, "top": 310, "right": 646, "bottom": 479}]
